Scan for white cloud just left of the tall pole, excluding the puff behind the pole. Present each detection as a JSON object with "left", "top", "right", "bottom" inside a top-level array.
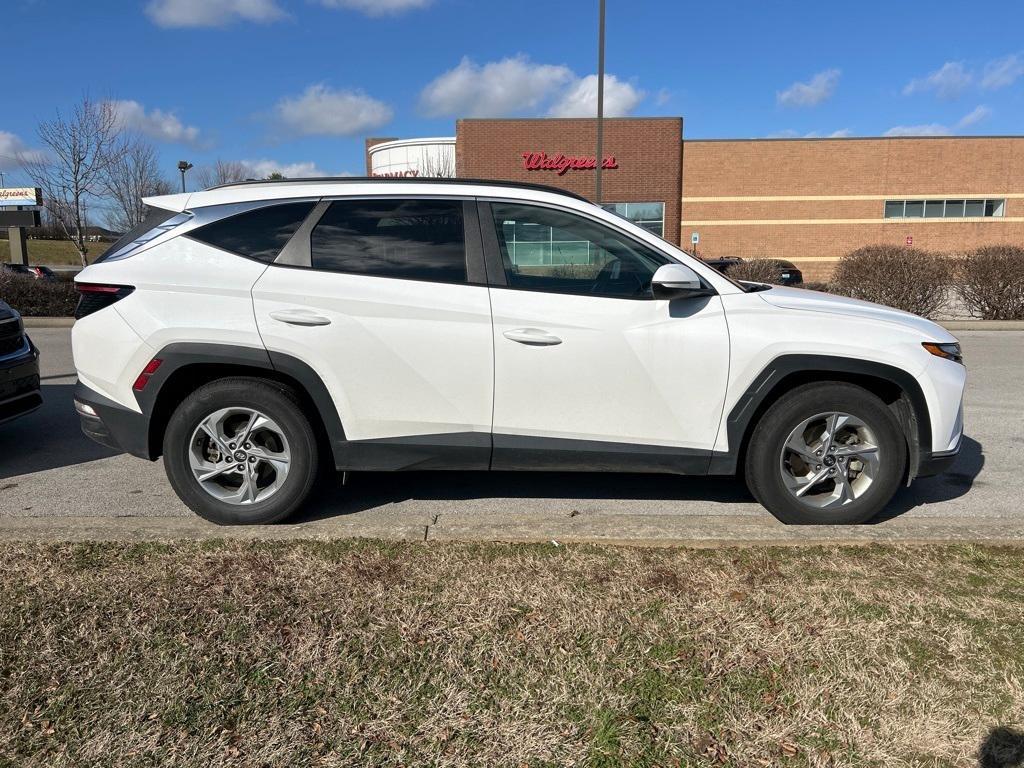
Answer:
[{"left": 420, "top": 54, "right": 577, "bottom": 118}]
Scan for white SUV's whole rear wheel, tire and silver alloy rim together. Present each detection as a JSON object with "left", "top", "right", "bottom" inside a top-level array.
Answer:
[{"left": 164, "top": 378, "right": 317, "bottom": 525}]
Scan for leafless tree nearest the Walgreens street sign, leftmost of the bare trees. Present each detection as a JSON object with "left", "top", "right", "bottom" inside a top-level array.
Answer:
[{"left": 18, "top": 96, "right": 124, "bottom": 266}]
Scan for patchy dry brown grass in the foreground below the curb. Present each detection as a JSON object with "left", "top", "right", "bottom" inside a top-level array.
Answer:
[{"left": 0, "top": 541, "right": 1024, "bottom": 766}]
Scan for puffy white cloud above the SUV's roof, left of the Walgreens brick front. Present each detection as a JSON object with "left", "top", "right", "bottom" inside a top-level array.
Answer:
[{"left": 274, "top": 83, "right": 394, "bottom": 136}]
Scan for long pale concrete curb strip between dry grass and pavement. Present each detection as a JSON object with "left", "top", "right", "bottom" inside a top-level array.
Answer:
[{"left": 0, "top": 513, "right": 1024, "bottom": 548}]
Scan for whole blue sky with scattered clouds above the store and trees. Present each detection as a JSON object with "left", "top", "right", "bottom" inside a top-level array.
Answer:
[{"left": 0, "top": 0, "right": 1024, "bottom": 182}]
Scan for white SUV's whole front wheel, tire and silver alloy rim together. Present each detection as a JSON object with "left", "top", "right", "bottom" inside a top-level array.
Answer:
[{"left": 745, "top": 382, "right": 907, "bottom": 524}]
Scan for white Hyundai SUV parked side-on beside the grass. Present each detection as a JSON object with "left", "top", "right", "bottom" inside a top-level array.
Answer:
[{"left": 73, "top": 179, "right": 966, "bottom": 523}]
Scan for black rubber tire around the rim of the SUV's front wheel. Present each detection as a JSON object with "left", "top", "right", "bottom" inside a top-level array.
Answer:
[{"left": 744, "top": 382, "right": 907, "bottom": 525}]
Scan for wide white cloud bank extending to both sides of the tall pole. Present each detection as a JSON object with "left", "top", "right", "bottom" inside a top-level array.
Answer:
[{"left": 420, "top": 54, "right": 644, "bottom": 118}]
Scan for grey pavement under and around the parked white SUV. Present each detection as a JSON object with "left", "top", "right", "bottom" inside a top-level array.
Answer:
[{"left": 0, "top": 328, "right": 1024, "bottom": 541}]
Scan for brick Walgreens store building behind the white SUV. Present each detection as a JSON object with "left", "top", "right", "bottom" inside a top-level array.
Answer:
[{"left": 367, "top": 123, "right": 1024, "bottom": 280}]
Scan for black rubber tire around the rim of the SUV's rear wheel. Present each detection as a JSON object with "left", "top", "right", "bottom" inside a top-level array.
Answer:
[{"left": 164, "top": 377, "right": 318, "bottom": 525}]
